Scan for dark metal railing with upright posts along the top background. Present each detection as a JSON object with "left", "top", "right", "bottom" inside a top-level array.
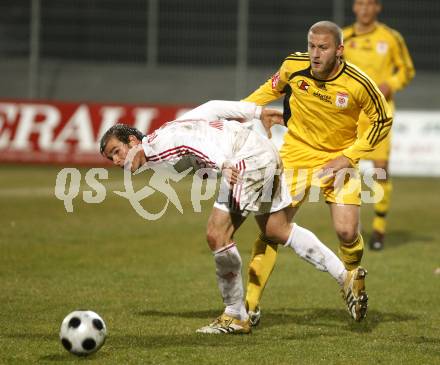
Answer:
[{"left": 0, "top": 0, "right": 440, "bottom": 98}]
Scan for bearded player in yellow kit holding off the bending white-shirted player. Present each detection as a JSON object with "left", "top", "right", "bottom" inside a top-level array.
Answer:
[{"left": 244, "top": 21, "right": 392, "bottom": 325}]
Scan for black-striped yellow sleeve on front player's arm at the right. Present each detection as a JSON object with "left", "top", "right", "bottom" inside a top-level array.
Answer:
[{"left": 342, "top": 75, "right": 393, "bottom": 163}]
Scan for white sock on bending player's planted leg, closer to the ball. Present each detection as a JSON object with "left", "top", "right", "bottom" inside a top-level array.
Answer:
[{"left": 214, "top": 243, "right": 248, "bottom": 320}]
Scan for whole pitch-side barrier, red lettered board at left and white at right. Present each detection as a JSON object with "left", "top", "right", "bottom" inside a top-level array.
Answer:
[{"left": 0, "top": 100, "right": 440, "bottom": 176}]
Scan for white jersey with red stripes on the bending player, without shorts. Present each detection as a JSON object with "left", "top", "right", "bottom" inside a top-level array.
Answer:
[{"left": 142, "top": 101, "right": 261, "bottom": 172}]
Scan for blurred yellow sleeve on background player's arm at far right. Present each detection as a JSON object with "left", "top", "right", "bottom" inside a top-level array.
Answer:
[{"left": 388, "top": 31, "right": 415, "bottom": 92}]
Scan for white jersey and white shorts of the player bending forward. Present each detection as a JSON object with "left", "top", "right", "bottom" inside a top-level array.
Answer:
[{"left": 142, "top": 101, "right": 291, "bottom": 215}]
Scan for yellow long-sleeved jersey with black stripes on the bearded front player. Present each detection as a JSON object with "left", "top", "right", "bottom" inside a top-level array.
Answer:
[{"left": 244, "top": 52, "right": 392, "bottom": 167}]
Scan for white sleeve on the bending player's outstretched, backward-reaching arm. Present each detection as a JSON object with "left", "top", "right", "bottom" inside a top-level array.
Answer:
[{"left": 178, "top": 100, "right": 262, "bottom": 122}]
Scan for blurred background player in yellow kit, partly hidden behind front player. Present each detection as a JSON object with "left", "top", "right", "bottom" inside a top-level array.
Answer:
[{"left": 343, "top": 0, "right": 414, "bottom": 250}]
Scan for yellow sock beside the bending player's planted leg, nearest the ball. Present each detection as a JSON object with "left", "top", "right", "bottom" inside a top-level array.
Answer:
[{"left": 246, "top": 235, "right": 278, "bottom": 312}]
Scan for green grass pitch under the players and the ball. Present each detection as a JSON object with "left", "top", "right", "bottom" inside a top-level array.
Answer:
[{"left": 0, "top": 165, "right": 440, "bottom": 365}]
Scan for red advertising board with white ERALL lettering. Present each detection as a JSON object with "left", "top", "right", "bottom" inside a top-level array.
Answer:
[{"left": 0, "top": 101, "right": 192, "bottom": 165}]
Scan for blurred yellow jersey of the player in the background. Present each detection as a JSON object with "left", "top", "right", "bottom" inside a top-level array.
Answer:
[{"left": 343, "top": 23, "right": 415, "bottom": 93}]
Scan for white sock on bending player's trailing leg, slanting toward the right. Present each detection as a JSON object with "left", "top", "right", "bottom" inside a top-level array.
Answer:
[{"left": 284, "top": 223, "right": 347, "bottom": 286}]
